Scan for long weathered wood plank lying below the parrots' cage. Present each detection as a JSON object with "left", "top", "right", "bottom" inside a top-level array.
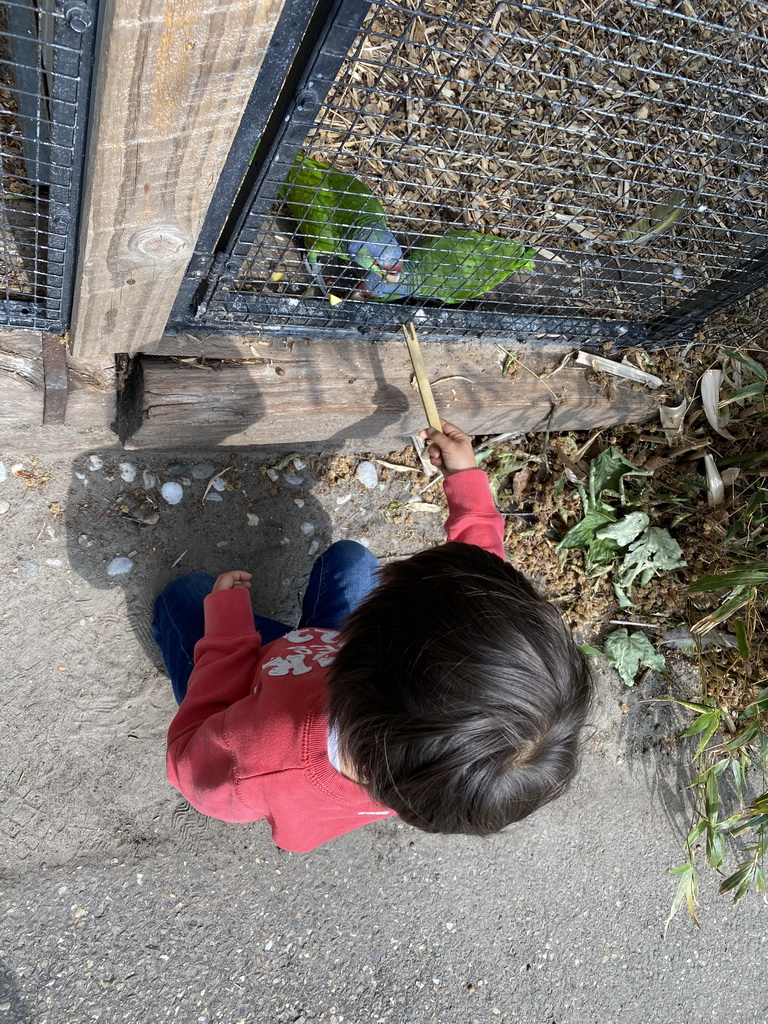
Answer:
[{"left": 119, "top": 341, "right": 657, "bottom": 449}]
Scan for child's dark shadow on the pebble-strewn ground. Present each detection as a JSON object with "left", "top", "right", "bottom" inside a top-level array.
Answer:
[{"left": 66, "top": 450, "right": 330, "bottom": 668}]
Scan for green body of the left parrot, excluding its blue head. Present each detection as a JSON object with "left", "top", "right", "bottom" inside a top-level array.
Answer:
[{"left": 281, "top": 155, "right": 391, "bottom": 260}]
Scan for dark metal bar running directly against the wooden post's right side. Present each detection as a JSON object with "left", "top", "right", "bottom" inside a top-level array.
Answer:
[{"left": 171, "top": 0, "right": 327, "bottom": 321}]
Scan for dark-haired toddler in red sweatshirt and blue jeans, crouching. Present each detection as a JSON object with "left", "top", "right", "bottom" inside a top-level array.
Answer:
[{"left": 153, "top": 421, "right": 590, "bottom": 852}]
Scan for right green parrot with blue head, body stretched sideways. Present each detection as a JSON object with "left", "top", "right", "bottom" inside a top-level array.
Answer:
[{"left": 359, "top": 231, "right": 536, "bottom": 303}]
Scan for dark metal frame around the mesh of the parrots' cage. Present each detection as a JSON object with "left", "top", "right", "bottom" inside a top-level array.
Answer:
[{"left": 169, "top": 0, "right": 768, "bottom": 347}]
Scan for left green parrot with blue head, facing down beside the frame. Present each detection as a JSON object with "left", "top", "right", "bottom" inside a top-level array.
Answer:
[{"left": 281, "top": 154, "right": 402, "bottom": 282}]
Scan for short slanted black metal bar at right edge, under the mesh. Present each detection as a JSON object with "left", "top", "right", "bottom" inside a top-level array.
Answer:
[{"left": 646, "top": 249, "right": 768, "bottom": 343}]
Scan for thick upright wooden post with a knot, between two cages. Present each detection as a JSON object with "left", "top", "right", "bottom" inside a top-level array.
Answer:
[{"left": 71, "top": 0, "right": 283, "bottom": 357}]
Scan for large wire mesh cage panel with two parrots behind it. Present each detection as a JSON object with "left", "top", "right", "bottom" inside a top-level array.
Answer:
[{"left": 196, "top": 0, "right": 768, "bottom": 346}]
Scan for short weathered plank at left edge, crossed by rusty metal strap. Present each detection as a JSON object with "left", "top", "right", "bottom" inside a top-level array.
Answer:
[{"left": 0, "top": 331, "right": 116, "bottom": 428}]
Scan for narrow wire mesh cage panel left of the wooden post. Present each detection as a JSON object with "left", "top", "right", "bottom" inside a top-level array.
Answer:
[{"left": 0, "top": 0, "right": 95, "bottom": 330}]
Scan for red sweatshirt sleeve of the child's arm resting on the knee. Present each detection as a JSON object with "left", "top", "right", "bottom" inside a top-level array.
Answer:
[{"left": 166, "top": 589, "right": 261, "bottom": 821}]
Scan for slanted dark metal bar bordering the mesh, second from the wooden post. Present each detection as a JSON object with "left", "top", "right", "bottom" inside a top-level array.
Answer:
[{"left": 195, "top": 0, "right": 371, "bottom": 307}]
